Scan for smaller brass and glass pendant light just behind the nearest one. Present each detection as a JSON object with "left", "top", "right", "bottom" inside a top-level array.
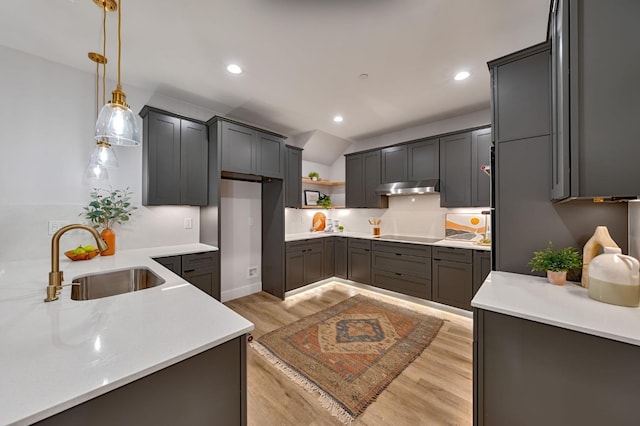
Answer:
[{"left": 85, "top": 0, "right": 118, "bottom": 183}]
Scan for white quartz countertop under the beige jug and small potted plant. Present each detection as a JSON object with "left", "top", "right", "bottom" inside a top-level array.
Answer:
[{"left": 471, "top": 271, "right": 640, "bottom": 346}]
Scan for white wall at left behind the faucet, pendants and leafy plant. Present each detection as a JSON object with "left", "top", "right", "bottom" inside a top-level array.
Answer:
[{"left": 0, "top": 46, "right": 214, "bottom": 260}]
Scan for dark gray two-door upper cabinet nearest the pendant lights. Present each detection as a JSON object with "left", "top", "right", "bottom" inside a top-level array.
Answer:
[{"left": 140, "top": 106, "right": 208, "bottom": 206}]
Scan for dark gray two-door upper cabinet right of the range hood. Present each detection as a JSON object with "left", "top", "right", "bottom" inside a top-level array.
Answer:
[{"left": 440, "top": 128, "right": 491, "bottom": 207}]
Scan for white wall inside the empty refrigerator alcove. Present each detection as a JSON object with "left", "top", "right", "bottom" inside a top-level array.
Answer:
[{"left": 220, "top": 179, "right": 262, "bottom": 302}]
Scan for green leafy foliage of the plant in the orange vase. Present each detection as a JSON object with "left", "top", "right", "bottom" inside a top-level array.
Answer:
[{"left": 81, "top": 187, "right": 137, "bottom": 229}]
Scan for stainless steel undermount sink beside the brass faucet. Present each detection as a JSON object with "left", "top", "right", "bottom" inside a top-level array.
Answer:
[{"left": 71, "top": 267, "right": 165, "bottom": 300}]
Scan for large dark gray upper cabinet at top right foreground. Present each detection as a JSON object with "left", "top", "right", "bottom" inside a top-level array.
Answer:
[{"left": 549, "top": 0, "right": 640, "bottom": 200}]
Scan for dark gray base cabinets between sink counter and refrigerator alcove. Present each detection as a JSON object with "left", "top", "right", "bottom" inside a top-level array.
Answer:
[{"left": 153, "top": 251, "right": 221, "bottom": 300}]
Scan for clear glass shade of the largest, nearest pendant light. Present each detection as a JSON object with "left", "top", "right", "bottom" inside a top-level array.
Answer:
[{"left": 96, "top": 101, "right": 141, "bottom": 146}]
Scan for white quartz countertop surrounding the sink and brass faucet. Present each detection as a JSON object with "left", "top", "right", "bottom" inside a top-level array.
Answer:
[{"left": 0, "top": 244, "right": 253, "bottom": 425}]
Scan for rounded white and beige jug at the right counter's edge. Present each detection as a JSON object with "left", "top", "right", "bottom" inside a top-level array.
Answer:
[{"left": 589, "top": 247, "right": 640, "bottom": 307}]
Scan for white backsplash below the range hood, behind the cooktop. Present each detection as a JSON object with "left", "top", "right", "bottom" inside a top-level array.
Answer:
[{"left": 285, "top": 194, "right": 490, "bottom": 238}]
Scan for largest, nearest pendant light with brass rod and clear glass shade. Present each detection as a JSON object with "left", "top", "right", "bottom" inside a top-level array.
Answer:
[{"left": 94, "top": 0, "right": 141, "bottom": 146}]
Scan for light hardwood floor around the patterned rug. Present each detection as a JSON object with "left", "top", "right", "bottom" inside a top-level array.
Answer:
[{"left": 225, "top": 282, "right": 473, "bottom": 426}]
